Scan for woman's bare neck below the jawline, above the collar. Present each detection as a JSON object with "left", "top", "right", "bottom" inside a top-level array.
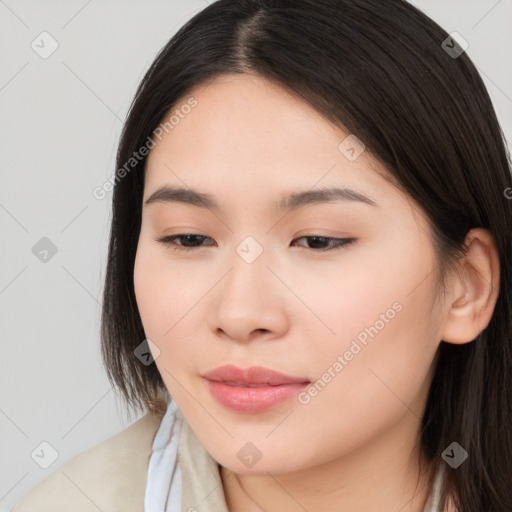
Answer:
[{"left": 221, "top": 413, "right": 434, "bottom": 512}]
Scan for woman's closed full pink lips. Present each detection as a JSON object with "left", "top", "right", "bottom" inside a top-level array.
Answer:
[{"left": 202, "top": 365, "right": 311, "bottom": 413}]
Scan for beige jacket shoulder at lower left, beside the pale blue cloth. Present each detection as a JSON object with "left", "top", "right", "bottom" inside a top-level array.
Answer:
[{"left": 11, "top": 413, "right": 162, "bottom": 512}]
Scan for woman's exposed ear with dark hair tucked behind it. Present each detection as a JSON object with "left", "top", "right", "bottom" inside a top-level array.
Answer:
[{"left": 441, "top": 228, "right": 500, "bottom": 344}]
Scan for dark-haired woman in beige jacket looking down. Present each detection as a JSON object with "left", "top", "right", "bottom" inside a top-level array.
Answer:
[{"left": 14, "top": 0, "right": 512, "bottom": 512}]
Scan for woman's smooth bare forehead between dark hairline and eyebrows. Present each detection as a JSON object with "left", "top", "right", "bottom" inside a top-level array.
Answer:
[{"left": 144, "top": 75, "right": 404, "bottom": 214}]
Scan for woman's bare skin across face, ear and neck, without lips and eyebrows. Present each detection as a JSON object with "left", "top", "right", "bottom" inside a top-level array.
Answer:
[{"left": 134, "top": 75, "right": 499, "bottom": 512}]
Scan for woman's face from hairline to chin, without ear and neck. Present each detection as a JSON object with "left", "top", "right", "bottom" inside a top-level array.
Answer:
[{"left": 134, "top": 75, "right": 443, "bottom": 473}]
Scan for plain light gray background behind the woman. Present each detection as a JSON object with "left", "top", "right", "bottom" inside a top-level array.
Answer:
[{"left": 0, "top": 0, "right": 512, "bottom": 512}]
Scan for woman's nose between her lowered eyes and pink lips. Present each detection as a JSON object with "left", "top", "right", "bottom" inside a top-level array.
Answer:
[{"left": 209, "top": 249, "right": 290, "bottom": 342}]
